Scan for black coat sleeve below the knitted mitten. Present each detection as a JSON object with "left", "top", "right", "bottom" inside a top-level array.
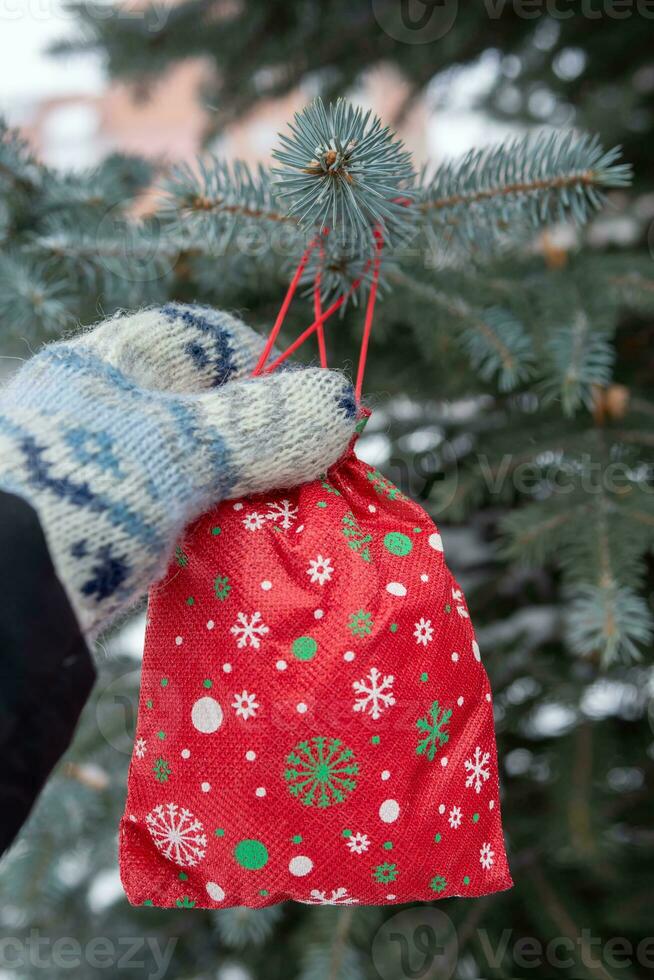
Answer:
[{"left": 0, "top": 491, "right": 95, "bottom": 853}]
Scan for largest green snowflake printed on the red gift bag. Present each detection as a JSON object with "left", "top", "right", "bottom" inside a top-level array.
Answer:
[{"left": 284, "top": 735, "right": 359, "bottom": 807}]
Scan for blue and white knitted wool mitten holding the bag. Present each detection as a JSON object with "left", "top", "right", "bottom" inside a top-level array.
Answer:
[{"left": 0, "top": 304, "right": 356, "bottom": 637}]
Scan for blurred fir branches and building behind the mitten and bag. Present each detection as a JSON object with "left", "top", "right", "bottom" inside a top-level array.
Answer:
[{"left": 0, "top": 0, "right": 654, "bottom": 980}]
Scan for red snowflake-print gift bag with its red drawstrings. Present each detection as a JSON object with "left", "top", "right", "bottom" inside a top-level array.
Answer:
[{"left": 120, "top": 234, "right": 511, "bottom": 908}]
